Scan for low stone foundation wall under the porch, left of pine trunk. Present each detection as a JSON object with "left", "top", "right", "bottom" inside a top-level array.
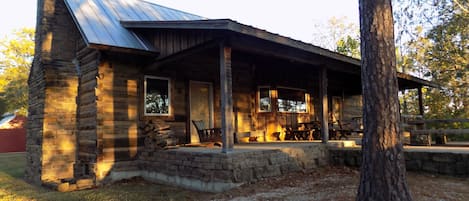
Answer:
[{"left": 103, "top": 143, "right": 328, "bottom": 192}]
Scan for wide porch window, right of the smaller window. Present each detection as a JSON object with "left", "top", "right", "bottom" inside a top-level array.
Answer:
[{"left": 277, "top": 88, "right": 306, "bottom": 113}]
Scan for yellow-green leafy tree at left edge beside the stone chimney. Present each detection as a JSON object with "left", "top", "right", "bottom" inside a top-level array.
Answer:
[{"left": 0, "top": 28, "right": 34, "bottom": 114}]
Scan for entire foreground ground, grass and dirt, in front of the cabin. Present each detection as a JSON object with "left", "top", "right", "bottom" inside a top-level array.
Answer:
[{"left": 0, "top": 153, "right": 469, "bottom": 201}]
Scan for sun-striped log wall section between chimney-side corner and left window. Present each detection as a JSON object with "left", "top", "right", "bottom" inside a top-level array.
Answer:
[{"left": 95, "top": 57, "right": 143, "bottom": 183}]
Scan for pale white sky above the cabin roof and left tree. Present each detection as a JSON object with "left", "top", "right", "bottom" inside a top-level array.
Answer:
[{"left": 0, "top": 0, "right": 358, "bottom": 42}]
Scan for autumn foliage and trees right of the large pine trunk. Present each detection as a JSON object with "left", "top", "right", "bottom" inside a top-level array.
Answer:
[{"left": 396, "top": 0, "right": 469, "bottom": 118}]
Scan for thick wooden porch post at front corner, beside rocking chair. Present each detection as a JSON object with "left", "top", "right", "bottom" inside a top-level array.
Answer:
[{"left": 220, "top": 42, "right": 234, "bottom": 153}]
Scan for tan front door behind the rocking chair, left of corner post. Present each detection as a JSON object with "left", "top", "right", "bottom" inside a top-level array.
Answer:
[{"left": 189, "top": 81, "right": 213, "bottom": 143}]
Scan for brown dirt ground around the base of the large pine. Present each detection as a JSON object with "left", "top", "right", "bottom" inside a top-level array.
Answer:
[{"left": 187, "top": 167, "right": 469, "bottom": 201}]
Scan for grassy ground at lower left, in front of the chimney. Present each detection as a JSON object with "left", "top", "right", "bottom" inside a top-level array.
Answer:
[{"left": 0, "top": 153, "right": 208, "bottom": 201}]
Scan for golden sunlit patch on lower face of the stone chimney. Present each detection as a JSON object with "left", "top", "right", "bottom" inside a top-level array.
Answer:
[{"left": 41, "top": 77, "right": 78, "bottom": 181}]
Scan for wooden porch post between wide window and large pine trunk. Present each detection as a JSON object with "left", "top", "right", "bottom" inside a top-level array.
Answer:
[{"left": 319, "top": 67, "right": 329, "bottom": 143}]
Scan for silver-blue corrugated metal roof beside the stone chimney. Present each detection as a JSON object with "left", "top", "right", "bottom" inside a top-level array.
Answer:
[{"left": 65, "top": 0, "right": 206, "bottom": 51}]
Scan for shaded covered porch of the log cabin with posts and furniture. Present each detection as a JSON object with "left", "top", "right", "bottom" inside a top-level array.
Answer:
[{"left": 130, "top": 20, "right": 429, "bottom": 153}]
